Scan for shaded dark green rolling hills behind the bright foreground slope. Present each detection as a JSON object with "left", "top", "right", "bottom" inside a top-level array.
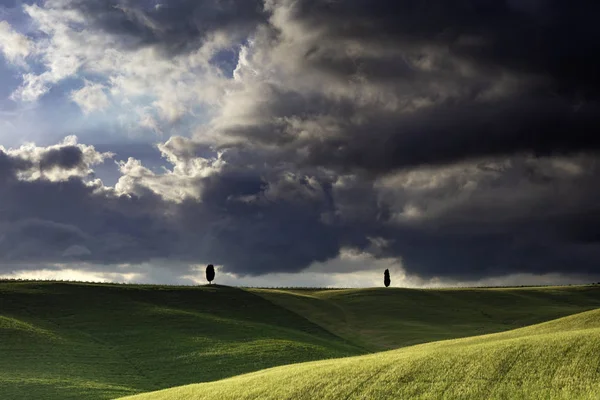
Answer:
[{"left": 0, "top": 282, "right": 600, "bottom": 399}]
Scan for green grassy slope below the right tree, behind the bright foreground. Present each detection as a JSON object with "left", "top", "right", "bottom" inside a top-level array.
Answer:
[{"left": 252, "top": 286, "right": 600, "bottom": 351}]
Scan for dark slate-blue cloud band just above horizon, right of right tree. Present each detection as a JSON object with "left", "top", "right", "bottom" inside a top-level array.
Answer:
[{"left": 386, "top": 198, "right": 600, "bottom": 279}]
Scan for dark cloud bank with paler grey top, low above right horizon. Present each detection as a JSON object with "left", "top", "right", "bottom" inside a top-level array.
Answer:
[{"left": 368, "top": 152, "right": 600, "bottom": 279}]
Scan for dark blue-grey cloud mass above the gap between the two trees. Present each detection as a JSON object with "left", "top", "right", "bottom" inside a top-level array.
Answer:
[{"left": 173, "top": 169, "right": 340, "bottom": 275}]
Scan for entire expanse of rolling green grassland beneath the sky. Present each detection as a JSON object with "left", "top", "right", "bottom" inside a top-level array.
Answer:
[{"left": 0, "top": 282, "right": 600, "bottom": 399}]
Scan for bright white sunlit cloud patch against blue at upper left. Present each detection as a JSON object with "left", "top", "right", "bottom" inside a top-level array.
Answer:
[{"left": 11, "top": 1, "right": 232, "bottom": 126}]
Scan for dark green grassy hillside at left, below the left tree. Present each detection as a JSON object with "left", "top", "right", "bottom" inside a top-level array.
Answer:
[{"left": 0, "top": 283, "right": 363, "bottom": 399}]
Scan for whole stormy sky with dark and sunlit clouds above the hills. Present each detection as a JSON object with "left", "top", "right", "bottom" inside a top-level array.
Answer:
[{"left": 0, "top": 0, "right": 600, "bottom": 287}]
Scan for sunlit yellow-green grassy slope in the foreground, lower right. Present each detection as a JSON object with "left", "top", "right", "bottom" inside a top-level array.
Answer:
[{"left": 122, "top": 310, "right": 600, "bottom": 400}]
